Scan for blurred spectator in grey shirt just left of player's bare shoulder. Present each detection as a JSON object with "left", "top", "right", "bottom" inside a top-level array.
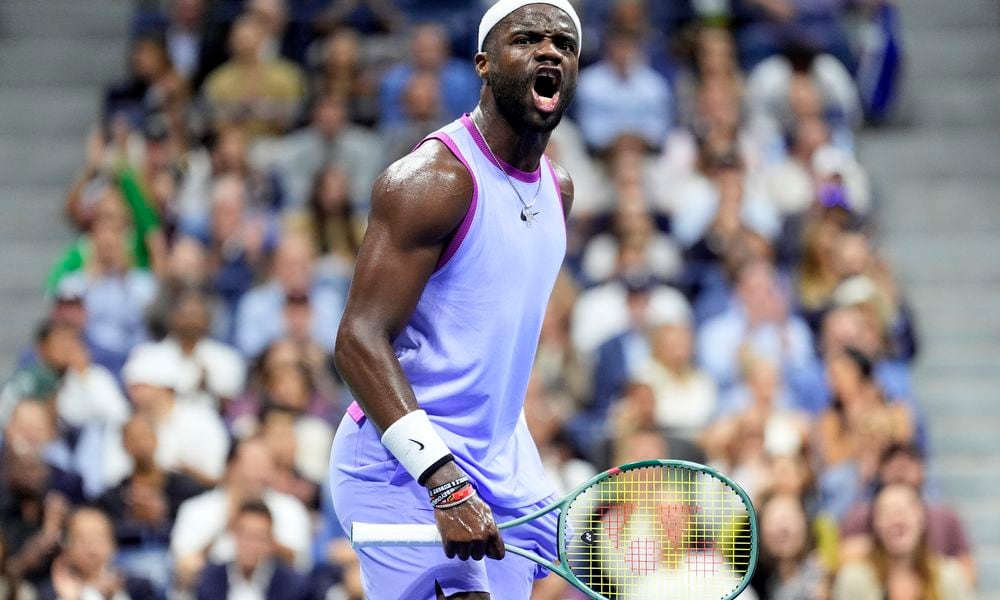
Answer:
[{"left": 261, "top": 95, "right": 384, "bottom": 209}]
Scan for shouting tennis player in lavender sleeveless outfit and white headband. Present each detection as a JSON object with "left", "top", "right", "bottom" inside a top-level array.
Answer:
[{"left": 330, "top": 0, "right": 581, "bottom": 600}]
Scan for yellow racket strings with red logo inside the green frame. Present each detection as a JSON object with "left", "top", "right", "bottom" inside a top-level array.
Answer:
[{"left": 564, "top": 465, "right": 752, "bottom": 600}]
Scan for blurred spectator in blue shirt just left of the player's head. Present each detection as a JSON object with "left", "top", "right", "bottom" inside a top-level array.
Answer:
[{"left": 379, "top": 24, "right": 482, "bottom": 127}]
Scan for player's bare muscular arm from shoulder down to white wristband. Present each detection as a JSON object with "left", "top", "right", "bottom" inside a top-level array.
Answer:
[{"left": 334, "top": 142, "right": 473, "bottom": 431}]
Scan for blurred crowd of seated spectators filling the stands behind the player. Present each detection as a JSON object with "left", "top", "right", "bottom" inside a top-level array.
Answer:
[{"left": 0, "top": 0, "right": 975, "bottom": 600}]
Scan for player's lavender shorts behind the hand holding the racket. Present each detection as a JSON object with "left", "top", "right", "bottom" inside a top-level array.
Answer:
[{"left": 330, "top": 416, "right": 558, "bottom": 600}]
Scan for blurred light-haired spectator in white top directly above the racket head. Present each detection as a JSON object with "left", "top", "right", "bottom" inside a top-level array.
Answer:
[{"left": 637, "top": 317, "right": 716, "bottom": 440}]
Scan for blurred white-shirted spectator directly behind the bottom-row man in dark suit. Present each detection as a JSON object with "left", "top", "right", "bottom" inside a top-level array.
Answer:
[{"left": 170, "top": 439, "right": 310, "bottom": 587}]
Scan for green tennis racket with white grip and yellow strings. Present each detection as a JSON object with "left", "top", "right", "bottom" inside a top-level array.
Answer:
[{"left": 351, "top": 460, "right": 758, "bottom": 600}]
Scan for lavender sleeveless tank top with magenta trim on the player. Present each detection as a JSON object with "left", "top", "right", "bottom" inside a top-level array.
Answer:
[{"left": 394, "top": 116, "right": 566, "bottom": 507}]
